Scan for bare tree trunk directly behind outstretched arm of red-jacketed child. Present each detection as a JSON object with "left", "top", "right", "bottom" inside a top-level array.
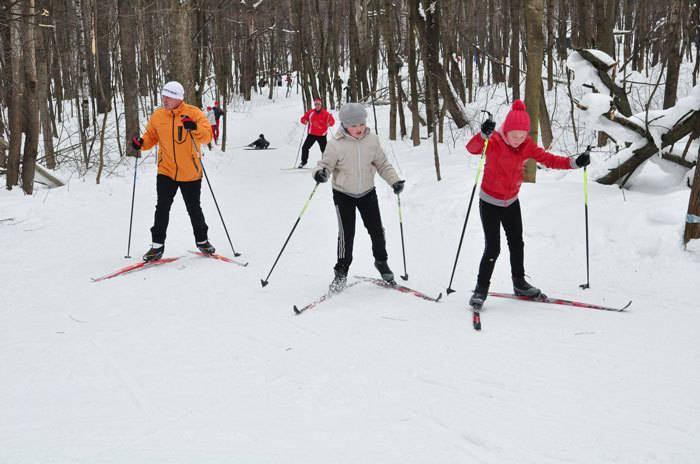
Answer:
[{"left": 523, "top": 0, "right": 544, "bottom": 182}]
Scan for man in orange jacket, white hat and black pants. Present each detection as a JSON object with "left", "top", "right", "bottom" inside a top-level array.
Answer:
[{"left": 131, "top": 81, "right": 215, "bottom": 261}]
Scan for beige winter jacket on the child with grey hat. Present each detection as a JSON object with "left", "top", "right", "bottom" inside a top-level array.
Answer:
[{"left": 311, "top": 127, "right": 401, "bottom": 195}]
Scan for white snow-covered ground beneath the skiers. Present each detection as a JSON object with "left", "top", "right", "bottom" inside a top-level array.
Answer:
[{"left": 0, "top": 89, "right": 700, "bottom": 463}]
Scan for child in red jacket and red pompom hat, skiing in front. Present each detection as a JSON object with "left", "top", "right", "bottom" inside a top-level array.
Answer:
[{"left": 467, "top": 100, "right": 591, "bottom": 307}]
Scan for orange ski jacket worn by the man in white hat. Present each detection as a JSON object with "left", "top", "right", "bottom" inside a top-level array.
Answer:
[{"left": 141, "top": 102, "right": 212, "bottom": 182}]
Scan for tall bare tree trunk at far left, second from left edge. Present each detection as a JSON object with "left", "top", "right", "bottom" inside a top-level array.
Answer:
[{"left": 22, "top": 0, "right": 39, "bottom": 195}]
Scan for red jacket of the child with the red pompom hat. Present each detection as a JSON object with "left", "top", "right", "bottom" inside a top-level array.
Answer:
[{"left": 467, "top": 132, "right": 572, "bottom": 201}]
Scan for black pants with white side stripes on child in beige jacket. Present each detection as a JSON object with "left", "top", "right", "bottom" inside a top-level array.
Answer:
[{"left": 333, "top": 190, "right": 387, "bottom": 273}]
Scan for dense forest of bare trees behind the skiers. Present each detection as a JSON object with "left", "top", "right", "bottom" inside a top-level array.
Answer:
[{"left": 0, "top": 0, "right": 700, "bottom": 242}]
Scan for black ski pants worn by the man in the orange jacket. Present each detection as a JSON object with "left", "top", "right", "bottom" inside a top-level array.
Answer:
[{"left": 151, "top": 174, "right": 209, "bottom": 243}]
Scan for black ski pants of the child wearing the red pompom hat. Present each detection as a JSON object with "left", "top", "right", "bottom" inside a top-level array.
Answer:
[{"left": 477, "top": 200, "right": 525, "bottom": 288}]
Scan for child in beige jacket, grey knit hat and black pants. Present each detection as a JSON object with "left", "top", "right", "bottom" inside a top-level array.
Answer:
[{"left": 312, "top": 103, "right": 405, "bottom": 292}]
